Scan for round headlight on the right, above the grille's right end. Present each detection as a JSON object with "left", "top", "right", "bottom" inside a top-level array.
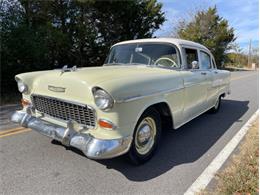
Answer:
[{"left": 93, "top": 89, "right": 114, "bottom": 110}]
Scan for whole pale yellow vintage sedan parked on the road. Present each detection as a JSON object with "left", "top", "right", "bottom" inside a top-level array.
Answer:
[{"left": 12, "top": 38, "right": 230, "bottom": 164}]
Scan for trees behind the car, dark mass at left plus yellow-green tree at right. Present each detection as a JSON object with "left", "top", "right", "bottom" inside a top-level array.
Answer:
[{"left": 0, "top": 0, "right": 256, "bottom": 103}]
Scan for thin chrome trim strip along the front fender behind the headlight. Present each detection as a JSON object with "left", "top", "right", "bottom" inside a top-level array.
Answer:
[{"left": 115, "top": 87, "right": 184, "bottom": 104}]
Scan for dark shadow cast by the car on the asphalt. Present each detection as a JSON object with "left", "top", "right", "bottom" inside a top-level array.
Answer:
[{"left": 53, "top": 100, "right": 249, "bottom": 181}]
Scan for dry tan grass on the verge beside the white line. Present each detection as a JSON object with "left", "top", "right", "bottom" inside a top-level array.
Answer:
[{"left": 202, "top": 120, "right": 259, "bottom": 195}]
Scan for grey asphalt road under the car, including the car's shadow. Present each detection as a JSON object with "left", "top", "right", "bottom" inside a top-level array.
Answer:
[{"left": 0, "top": 71, "right": 258, "bottom": 194}]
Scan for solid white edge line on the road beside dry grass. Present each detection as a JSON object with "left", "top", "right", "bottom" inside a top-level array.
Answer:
[{"left": 184, "top": 110, "right": 258, "bottom": 195}]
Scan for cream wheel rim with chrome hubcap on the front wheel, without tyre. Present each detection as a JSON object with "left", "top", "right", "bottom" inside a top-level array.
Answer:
[{"left": 135, "top": 117, "right": 157, "bottom": 155}]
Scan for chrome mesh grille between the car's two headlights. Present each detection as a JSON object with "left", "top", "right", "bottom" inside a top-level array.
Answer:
[{"left": 31, "top": 95, "right": 96, "bottom": 128}]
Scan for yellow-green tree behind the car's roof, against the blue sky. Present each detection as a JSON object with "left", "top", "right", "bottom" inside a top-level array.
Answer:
[{"left": 176, "top": 7, "right": 236, "bottom": 67}]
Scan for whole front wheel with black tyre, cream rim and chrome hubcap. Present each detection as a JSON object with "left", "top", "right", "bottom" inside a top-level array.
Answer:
[{"left": 128, "top": 108, "right": 161, "bottom": 165}]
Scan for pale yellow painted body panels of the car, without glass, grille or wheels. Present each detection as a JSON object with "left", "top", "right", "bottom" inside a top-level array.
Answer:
[{"left": 13, "top": 38, "right": 230, "bottom": 158}]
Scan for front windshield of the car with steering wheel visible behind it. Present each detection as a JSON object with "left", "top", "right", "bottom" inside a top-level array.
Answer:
[{"left": 105, "top": 43, "right": 180, "bottom": 68}]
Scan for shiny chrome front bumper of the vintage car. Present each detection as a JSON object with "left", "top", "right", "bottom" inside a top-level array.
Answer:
[{"left": 11, "top": 111, "right": 132, "bottom": 159}]
